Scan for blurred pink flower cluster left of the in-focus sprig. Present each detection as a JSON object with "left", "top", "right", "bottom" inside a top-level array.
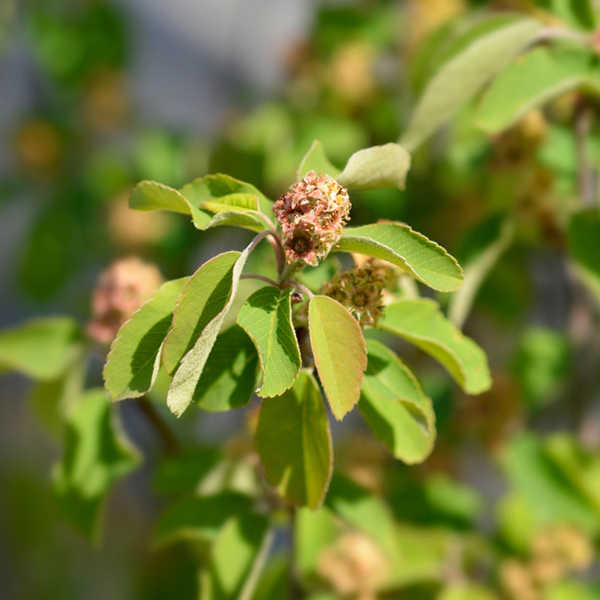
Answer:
[{"left": 87, "top": 258, "right": 162, "bottom": 345}]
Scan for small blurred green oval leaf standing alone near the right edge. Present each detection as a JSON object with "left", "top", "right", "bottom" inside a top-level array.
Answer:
[{"left": 514, "top": 327, "right": 572, "bottom": 406}]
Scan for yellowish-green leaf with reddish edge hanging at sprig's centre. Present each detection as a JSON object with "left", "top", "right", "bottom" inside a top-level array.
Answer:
[{"left": 308, "top": 296, "right": 367, "bottom": 420}]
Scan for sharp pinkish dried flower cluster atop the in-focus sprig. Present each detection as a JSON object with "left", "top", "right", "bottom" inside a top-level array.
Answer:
[{"left": 273, "top": 171, "right": 350, "bottom": 267}]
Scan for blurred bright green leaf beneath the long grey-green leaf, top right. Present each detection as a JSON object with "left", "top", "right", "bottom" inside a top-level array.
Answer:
[{"left": 475, "top": 48, "right": 600, "bottom": 133}]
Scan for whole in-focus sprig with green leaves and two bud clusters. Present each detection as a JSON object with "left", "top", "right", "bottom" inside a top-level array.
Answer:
[{"left": 104, "top": 142, "right": 490, "bottom": 508}]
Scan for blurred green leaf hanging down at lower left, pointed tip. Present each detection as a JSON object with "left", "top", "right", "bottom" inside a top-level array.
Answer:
[{"left": 53, "top": 389, "right": 140, "bottom": 540}]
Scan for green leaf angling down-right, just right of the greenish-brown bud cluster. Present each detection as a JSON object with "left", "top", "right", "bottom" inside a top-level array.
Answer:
[{"left": 379, "top": 298, "right": 492, "bottom": 394}]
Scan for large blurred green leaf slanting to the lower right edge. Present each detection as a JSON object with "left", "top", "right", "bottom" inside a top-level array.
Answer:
[{"left": 502, "top": 434, "right": 600, "bottom": 532}]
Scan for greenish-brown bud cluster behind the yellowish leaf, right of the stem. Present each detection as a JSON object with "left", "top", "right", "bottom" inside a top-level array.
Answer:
[{"left": 321, "top": 262, "right": 386, "bottom": 327}]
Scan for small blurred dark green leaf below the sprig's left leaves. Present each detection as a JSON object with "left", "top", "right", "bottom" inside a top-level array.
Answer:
[{"left": 154, "top": 446, "right": 221, "bottom": 494}]
